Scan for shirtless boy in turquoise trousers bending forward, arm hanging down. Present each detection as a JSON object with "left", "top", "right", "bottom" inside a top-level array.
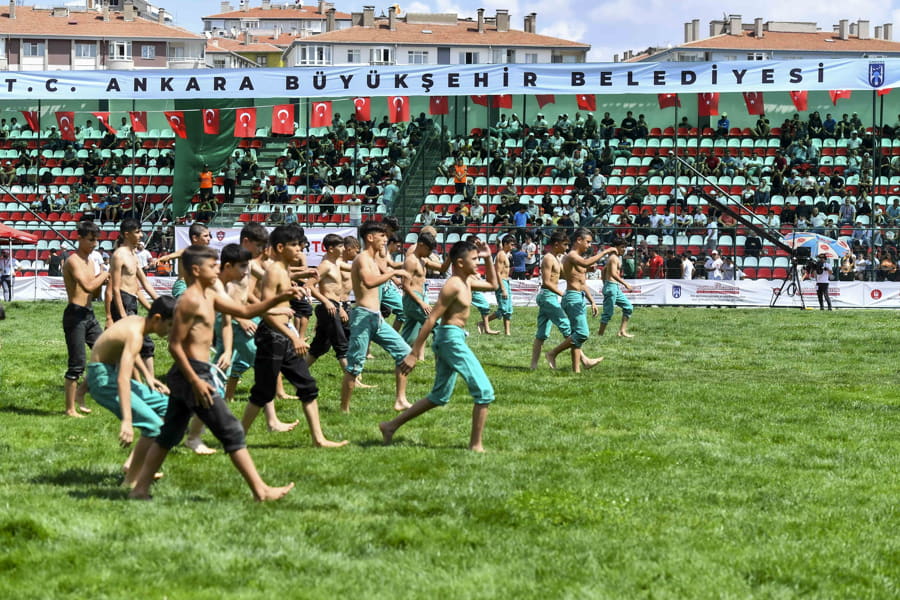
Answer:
[{"left": 87, "top": 296, "right": 175, "bottom": 487}]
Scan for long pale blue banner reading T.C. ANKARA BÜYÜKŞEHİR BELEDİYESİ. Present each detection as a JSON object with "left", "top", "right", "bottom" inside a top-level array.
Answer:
[{"left": 0, "top": 58, "right": 900, "bottom": 100}]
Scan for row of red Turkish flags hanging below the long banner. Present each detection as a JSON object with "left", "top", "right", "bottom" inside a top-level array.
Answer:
[{"left": 21, "top": 88, "right": 891, "bottom": 141}]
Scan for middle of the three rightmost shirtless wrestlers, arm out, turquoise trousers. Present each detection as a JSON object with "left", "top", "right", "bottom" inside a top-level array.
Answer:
[{"left": 561, "top": 227, "right": 615, "bottom": 373}]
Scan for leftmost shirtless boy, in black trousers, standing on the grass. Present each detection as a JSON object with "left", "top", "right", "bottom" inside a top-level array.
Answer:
[{"left": 63, "top": 221, "right": 109, "bottom": 417}]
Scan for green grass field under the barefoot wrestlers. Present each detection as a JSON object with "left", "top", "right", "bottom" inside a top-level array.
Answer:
[{"left": 0, "top": 303, "right": 900, "bottom": 599}]
